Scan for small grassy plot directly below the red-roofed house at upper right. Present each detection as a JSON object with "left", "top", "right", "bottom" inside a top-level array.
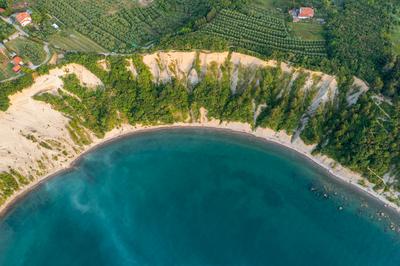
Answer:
[{"left": 288, "top": 22, "right": 324, "bottom": 41}]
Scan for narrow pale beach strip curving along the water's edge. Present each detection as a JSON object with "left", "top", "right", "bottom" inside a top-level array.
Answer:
[{"left": 0, "top": 120, "right": 400, "bottom": 219}]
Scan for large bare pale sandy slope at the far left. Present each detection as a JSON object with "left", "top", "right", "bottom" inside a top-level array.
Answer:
[{"left": 0, "top": 64, "right": 102, "bottom": 178}]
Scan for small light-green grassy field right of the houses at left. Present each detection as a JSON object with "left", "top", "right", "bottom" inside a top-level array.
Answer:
[{"left": 49, "top": 30, "right": 107, "bottom": 53}]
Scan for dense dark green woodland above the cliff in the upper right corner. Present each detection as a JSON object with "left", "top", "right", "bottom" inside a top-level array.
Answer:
[{"left": 326, "top": 0, "right": 399, "bottom": 86}]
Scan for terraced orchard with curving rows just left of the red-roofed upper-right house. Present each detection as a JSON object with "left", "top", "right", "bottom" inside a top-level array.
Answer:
[{"left": 201, "top": 10, "right": 326, "bottom": 58}]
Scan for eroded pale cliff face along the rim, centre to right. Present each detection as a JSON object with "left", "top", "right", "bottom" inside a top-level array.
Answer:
[{"left": 143, "top": 52, "right": 368, "bottom": 128}]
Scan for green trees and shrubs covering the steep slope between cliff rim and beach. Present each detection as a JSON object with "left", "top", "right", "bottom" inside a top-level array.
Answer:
[{"left": 30, "top": 55, "right": 400, "bottom": 202}]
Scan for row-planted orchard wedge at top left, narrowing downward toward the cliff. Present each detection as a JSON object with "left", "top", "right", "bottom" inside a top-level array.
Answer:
[{"left": 35, "top": 0, "right": 209, "bottom": 53}]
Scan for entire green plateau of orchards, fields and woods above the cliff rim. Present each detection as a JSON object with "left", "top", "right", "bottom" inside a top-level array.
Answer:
[{"left": 0, "top": 0, "right": 394, "bottom": 100}]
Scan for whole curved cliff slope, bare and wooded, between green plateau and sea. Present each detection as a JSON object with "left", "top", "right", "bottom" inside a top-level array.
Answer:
[{"left": 0, "top": 52, "right": 400, "bottom": 211}]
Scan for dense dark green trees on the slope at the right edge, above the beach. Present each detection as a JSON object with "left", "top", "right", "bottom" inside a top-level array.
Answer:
[{"left": 317, "top": 95, "right": 400, "bottom": 189}]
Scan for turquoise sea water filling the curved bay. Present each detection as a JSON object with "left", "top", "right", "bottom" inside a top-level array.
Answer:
[{"left": 0, "top": 129, "right": 400, "bottom": 266}]
